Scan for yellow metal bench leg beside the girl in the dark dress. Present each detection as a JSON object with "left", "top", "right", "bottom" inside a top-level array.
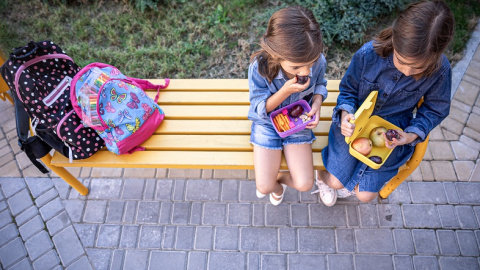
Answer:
[{"left": 379, "top": 135, "right": 430, "bottom": 199}]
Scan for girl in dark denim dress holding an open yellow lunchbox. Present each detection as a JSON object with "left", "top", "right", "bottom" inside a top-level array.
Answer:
[{"left": 317, "top": 1, "right": 454, "bottom": 206}]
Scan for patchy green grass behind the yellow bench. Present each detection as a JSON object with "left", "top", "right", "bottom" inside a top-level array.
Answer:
[{"left": 0, "top": 0, "right": 480, "bottom": 79}]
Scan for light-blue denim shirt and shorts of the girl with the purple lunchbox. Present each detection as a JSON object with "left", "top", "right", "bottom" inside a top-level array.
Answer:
[{"left": 248, "top": 54, "right": 327, "bottom": 150}]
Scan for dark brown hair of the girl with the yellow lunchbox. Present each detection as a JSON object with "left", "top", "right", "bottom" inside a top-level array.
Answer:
[{"left": 373, "top": 1, "right": 455, "bottom": 79}]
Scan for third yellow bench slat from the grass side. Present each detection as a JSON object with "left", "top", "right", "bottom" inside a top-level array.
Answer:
[{"left": 161, "top": 105, "right": 333, "bottom": 120}]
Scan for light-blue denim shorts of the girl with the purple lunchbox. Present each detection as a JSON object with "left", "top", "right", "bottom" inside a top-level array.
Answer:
[{"left": 250, "top": 122, "right": 316, "bottom": 150}]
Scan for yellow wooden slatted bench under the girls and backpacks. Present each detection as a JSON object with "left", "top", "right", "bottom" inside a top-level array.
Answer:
[{"left": 42, "top": 79, "right": 426, "bottom": 198}]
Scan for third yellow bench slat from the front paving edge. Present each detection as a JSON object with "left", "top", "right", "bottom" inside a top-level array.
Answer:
[{"left": 155, "top": 119, "right": 331, "bottom": 136}]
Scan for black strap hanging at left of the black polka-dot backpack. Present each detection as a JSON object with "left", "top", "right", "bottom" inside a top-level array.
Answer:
[{"left": 12, "top": 90, "right": 52, "bottom": 173}]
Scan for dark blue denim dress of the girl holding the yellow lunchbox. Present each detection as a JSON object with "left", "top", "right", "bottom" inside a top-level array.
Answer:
[{"left": 322, "top": 41, "right": 452, "bottom": 192}]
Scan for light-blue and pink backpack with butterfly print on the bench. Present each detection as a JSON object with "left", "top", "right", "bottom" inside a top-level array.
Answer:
[{"left": 70, "top": 63, "right": 170, "bottom": 155}]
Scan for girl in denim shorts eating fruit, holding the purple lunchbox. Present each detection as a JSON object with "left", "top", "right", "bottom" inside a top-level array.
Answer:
[{"left": 248, "top": 6, "right": 327, "bottom": 205}]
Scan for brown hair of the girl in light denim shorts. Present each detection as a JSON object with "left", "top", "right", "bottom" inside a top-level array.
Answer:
[{"left": 250, "top": 6, "right": 323, "bottom": 82}]
